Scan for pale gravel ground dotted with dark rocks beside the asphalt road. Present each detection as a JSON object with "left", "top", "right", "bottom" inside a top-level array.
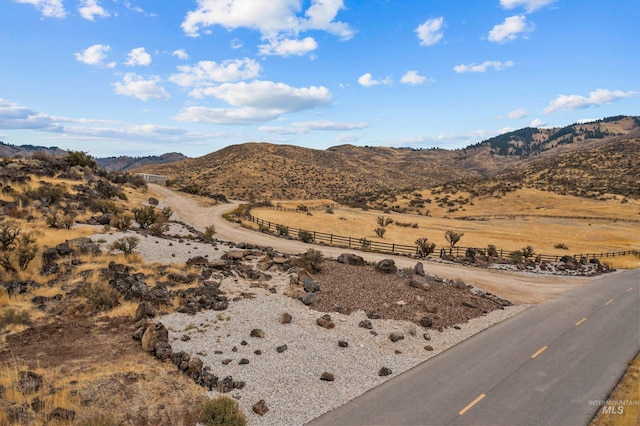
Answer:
[{"left": 159, "top": 266, "right": 528, "bottom": 425}]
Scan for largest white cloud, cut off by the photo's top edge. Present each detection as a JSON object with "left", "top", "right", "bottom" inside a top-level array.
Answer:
[{"left": 181, "top": 0, "right": 354, "bottom": 56}]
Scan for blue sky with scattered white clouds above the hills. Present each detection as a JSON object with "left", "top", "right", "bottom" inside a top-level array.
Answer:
[{"left": 0, "top": 0, "right": 640, "bottom": 156}]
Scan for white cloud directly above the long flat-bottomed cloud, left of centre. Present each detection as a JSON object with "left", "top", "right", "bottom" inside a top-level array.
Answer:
[{"left": 169, "top": 58, "right": 261, "bottom": 87}]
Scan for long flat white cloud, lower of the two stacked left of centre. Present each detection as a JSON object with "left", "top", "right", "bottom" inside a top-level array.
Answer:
[{"left": 202, "top": 80, "right": 332, "bottom": 114}]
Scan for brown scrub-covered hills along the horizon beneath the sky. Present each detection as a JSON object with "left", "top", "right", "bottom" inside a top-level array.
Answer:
[{"left": 140, "top": 116, "right": 640, "bottom": 204}]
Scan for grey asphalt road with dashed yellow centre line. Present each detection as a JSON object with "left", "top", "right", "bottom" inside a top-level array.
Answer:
[{"left": 310, "top": 269, "right": 640, "bottom": 425}]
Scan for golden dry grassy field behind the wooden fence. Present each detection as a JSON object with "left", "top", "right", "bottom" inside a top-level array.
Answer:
[{"left": 253, "top": 189, "right": 640, "bottom": 268}]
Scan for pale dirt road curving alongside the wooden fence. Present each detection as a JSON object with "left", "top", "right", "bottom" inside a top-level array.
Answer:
[{"left": 149, "top": 184, "right": 599, "bottom": 304}]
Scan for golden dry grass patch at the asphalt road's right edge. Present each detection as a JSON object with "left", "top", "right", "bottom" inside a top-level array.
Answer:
[{"left": 589, "top": 354, "right": 640, "bottom": 426}]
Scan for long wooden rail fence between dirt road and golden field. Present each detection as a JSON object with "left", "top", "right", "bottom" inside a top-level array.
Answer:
[{"left": 248, "top": 205, "right": 640, "bottom": 262}]
